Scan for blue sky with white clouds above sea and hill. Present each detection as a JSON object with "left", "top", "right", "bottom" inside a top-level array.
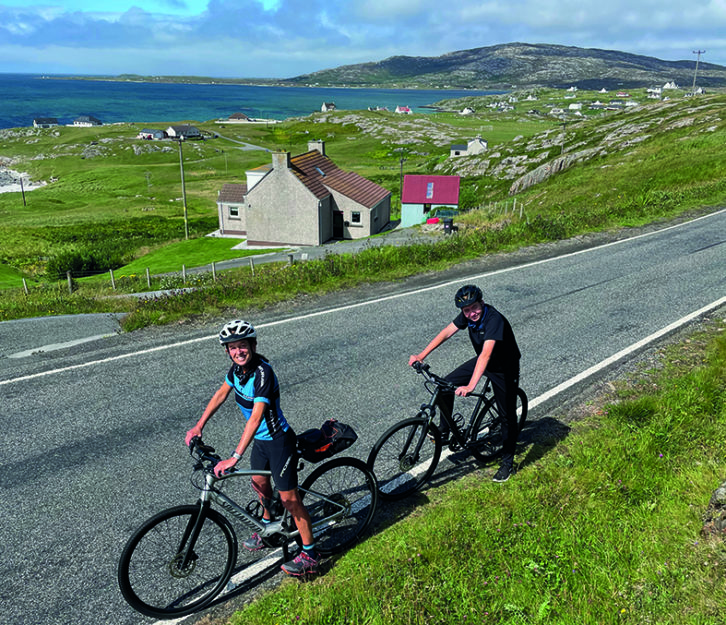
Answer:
[{"left": 0, "top": 0, "right": 726, "bottom": 78}]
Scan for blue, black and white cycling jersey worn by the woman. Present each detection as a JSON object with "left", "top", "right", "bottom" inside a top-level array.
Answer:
[{"left": 225, "top": 357, "right": 290, "bottom": 441}]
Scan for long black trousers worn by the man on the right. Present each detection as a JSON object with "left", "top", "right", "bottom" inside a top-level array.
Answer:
[{"left": 436, "top": 358, "right": 519, "bottom": 460}]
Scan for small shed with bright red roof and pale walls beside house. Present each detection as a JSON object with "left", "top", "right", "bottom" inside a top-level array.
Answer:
[{"left": 401, "top": 175, "right": 460, "bottom": 228}]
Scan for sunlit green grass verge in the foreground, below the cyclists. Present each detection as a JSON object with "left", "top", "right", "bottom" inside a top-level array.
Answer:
[{"left": 228, "top": 316, "right": 726, "bottom": 625}]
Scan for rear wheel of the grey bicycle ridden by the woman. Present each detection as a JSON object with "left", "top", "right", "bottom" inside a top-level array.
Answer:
[{"left": 300, "top": 457, "right": 378, "bottom": 556}]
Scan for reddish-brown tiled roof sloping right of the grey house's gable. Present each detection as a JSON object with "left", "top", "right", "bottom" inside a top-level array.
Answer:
[{"left": 290, "top": 150, "right": 390, "bottom": 208}]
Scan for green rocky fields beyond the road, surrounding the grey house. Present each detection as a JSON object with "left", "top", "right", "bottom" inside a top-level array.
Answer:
[{"left": 0, "top": 90, "right": 726, "bottom": 329}]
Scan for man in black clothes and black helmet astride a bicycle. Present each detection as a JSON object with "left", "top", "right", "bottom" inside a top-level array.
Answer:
[{"left": 408, "top": 284, "right": 521, "bottom": 482}]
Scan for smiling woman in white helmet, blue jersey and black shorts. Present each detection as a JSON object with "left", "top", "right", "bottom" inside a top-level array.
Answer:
[{"left": 186, "top": 320, "right": 318, "bottom": 576}]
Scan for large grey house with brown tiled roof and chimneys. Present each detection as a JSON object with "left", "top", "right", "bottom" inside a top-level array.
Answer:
[{"left": 217, "top": 141, "right": 391, "bottom": 246}]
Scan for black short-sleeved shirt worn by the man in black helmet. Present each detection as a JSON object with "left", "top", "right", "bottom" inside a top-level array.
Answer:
[{"left": 454, "top": 303, "right": 521, "bottom": 373}]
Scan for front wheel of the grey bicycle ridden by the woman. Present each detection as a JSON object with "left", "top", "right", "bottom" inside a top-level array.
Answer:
[{"left": 118, "top": 505, "right": 237, "bottom": 618}]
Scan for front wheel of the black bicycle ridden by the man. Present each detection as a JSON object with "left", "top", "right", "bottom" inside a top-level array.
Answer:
[{"left": 368, "top": 417, "right": 441, "bottom": 500}]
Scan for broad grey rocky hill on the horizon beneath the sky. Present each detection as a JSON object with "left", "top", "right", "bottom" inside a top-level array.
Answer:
[{"left": 284, "top": 43, "right": 726, "bottom": 89}]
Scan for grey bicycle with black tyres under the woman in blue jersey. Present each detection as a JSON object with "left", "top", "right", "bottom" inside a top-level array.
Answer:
[{"left": 118, "top": 437, "right": 378, "bottom": 618}]
